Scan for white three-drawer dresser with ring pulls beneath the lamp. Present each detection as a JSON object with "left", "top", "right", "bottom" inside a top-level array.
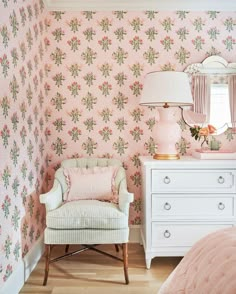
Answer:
[{"left": 140, "top": 156, "right": 236, "bottom": 268}]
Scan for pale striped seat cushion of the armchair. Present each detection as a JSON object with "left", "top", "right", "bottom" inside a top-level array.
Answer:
[{"left": 46, "top": 200, "right": 128, "bottom": 230}]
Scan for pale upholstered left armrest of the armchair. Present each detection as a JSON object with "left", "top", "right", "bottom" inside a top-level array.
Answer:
[{"left": 39, "top": 179, "right": 62, "bottom": 211}]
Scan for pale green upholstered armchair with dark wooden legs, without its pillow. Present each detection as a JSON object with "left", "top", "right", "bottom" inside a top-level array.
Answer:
[{"left": 40, "top": 158, "right": 133, "bottom": 285}]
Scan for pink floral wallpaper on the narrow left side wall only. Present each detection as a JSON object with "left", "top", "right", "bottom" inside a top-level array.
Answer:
[{"left": 0, "top": 0, "right": 47, "bottom": 288}]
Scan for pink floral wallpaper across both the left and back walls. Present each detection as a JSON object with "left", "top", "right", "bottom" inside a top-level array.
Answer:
[{"left": 0, "top": 0, "right": 236, "bottom": 287}]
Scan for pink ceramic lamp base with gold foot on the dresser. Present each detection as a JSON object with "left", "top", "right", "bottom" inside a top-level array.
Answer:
[{"left": 153, "top": 107, "right": 181, "bottom": 159}]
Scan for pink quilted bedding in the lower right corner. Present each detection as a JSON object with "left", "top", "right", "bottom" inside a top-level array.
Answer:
[{"left": 158, "top": 227, "right": 236, "bottom": 294}]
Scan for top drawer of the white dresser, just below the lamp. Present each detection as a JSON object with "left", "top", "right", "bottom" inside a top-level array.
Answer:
[{"left": 151, "top": 169, "right": 236, "bottom": 193}]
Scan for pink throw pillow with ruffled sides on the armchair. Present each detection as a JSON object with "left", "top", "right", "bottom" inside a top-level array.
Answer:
[{"left": 64, "top": 166, "right": 118, "bottom": 203}]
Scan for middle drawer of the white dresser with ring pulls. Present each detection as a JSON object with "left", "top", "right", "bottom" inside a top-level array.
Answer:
[{"left": 152, "top": 194, "right": 234, "bottom": 220}]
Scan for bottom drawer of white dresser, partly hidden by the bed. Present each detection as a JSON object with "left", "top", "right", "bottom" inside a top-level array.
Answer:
[{"left": 152, "top": 222, "right": 232, "bottom": 247}]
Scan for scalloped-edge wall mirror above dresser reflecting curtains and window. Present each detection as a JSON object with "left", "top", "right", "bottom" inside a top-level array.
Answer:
[{"left": 183, "top": 55, "right": 236, "bottom": 135}]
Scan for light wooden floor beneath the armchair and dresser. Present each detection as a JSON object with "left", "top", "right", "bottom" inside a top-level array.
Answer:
[{"left": 20, "top": 244, "right": 181, "bottom": 294}]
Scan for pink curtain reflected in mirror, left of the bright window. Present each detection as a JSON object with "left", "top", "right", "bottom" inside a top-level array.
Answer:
[{"left": 192, "top": 74, "right": 211, "bottom": 121}]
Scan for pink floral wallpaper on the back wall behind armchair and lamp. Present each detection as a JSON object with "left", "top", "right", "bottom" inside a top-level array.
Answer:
[{"left": 44, "top": 11, "right": 236, "bottom": 224}]
